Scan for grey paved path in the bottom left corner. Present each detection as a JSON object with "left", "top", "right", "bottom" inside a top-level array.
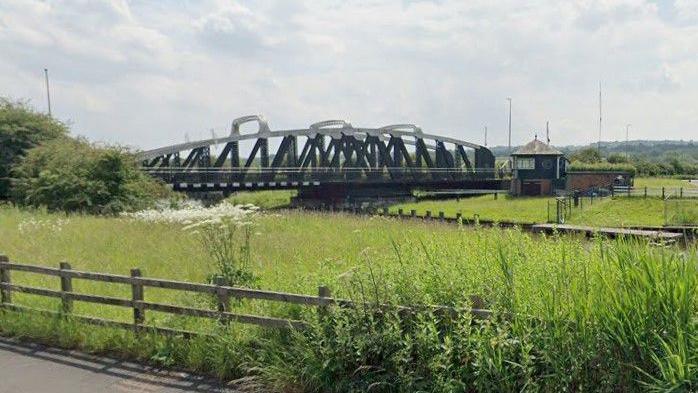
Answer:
[{"left": 0, "top": 337, "right": 245, "bottom": 393}]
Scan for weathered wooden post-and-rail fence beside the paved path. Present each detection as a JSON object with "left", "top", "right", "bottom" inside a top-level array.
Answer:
[{"left": 0, "top": 255, "right": 491, "bottom": 336}]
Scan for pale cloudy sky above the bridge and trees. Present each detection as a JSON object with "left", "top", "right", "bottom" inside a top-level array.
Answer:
[{"left": 0, "top": 0, "right": 698, "bottom": 149}]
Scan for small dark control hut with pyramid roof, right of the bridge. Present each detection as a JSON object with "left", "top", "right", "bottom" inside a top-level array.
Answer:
[{"left": 510, "top": 137, "right": 567, "bottom": 196}]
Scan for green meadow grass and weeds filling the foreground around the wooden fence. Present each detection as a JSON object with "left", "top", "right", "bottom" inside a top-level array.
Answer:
[{"left": 0, "top": 208, "right": 698, "bottom": 392}]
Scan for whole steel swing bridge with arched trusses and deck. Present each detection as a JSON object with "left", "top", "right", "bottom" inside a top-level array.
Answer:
[{"left": 138, "top": 115, "right": 499, "bottom": 195}]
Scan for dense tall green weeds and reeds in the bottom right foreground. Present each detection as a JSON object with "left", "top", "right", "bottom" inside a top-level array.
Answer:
[{"left": 263, "top": 240, "right": 698, "bottom": 392}]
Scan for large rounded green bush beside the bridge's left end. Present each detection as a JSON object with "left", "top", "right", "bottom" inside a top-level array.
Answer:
[{"left": 12, "top": 138, "right": 169, "bottom": 214}]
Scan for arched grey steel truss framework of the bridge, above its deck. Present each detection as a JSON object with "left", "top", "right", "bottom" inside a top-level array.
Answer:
[{"left": 138, "top": 115, "right": 494, "bottom": 186}]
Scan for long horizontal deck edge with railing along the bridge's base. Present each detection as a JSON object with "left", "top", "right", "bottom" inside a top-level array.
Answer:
[{"left": 142, "top": 167, "right": 502, "bottom": 184}]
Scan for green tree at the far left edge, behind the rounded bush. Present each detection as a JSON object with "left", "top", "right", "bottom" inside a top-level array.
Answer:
[{"left": 0, "top": 97, "right": 68, "bottom": 199}]
